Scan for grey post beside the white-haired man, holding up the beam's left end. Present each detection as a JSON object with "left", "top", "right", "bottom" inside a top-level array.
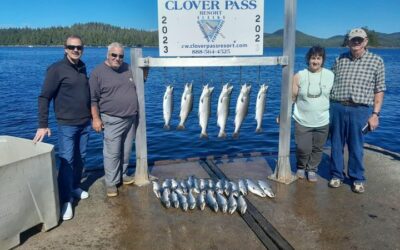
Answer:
[{"left": 131, "top": 48, "right": 150, "bottom": 186}]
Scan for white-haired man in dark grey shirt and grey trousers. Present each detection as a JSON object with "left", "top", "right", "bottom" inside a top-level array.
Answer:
[{"left": 89, "top": 42, "right": 145, "bottom": 197}]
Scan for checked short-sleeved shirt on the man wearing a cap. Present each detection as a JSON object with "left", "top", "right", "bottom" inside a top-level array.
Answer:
[{"left": 330, "top": 51, "right": 386, "bottom": 106}]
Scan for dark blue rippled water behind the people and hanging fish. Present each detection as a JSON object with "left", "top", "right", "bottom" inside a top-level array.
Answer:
[{"left": 0, "top": 47, "right": 400, "bottom": 167}]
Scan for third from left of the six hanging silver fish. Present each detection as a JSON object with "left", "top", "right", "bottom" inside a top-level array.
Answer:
[{"left": 199, "top": 84, "right": 214, "bottom": 138}]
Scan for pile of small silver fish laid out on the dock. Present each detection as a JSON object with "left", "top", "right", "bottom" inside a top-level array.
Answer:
[{"left": 153, "top": 176, "right": 275, "bottom": 214}]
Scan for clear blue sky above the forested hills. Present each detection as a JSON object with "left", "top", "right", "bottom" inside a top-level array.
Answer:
[{"left": 0, "top": 0, "right": 400, "bottom": 38}]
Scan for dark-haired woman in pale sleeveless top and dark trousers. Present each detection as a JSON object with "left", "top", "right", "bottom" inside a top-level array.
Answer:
[{"left": 292, "top": 46, "right": 334, "bottom": 182}]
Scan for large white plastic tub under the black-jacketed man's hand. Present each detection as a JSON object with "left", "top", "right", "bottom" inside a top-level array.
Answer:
[{"left": 0, "top": 136, "right": 60, "bottom": 249}]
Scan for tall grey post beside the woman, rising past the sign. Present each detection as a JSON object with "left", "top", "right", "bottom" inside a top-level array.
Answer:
[{"left": 269, "top": 0, "right": 296, "bottom": 184}]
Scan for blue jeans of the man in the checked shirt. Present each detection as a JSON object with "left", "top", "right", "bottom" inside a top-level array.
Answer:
[{"left": 330, "top": 102, "right": 371, "bottom": 182}]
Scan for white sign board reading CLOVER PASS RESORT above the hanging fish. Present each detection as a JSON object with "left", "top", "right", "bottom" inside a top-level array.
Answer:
[{"left": 158, "top": 0, "right": 264, "bottom": 56}]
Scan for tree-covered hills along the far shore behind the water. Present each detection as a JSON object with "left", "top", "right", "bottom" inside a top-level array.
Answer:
[{"left": 0, "top": 23, "right": 400, "bottom": 47}]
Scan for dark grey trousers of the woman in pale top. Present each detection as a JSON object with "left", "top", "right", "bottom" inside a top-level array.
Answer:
[{"left": 295, "top": 122, "right": 329, "bottom": 172}]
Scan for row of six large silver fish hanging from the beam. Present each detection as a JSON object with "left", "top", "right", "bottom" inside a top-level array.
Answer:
[{"left": 163, "top": 83, "right": 268, "bottom": 138}]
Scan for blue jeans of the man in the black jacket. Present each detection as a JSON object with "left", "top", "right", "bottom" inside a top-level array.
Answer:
[{"left": 58, "top": 122, "right": 90, "bottom": 204}]
